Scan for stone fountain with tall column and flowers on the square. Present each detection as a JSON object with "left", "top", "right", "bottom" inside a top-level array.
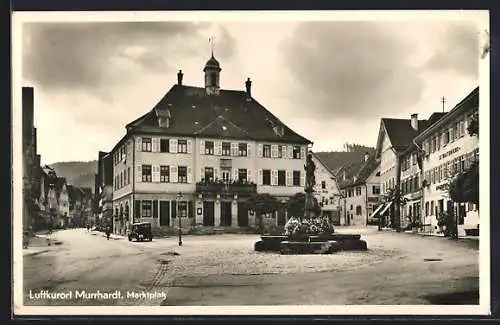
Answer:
[{"left": 254, "top": 152, "right": 367, "bottom": 254}]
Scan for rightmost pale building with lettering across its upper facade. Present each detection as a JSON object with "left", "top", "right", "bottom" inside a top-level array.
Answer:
[{"left": 415, "top": 88, "right": 479, "bottom": 235}]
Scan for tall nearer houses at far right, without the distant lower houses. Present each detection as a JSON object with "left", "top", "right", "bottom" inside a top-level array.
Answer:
[{"left": 376, "top": 87, "right": 479, "bottom": 234}]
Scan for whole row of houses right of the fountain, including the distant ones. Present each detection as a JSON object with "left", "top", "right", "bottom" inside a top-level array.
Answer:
[{"left": 319, "top": 87, "right": 479, "bottom": 235}]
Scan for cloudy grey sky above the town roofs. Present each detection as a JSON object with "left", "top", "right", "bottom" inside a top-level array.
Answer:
[{"left": 22, "top": 13, "right": 480, "bottom": 163}]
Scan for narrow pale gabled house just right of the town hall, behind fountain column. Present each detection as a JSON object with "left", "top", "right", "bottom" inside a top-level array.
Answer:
[{"left": 312, "top": 153, "right": 342, "bottom": 225}]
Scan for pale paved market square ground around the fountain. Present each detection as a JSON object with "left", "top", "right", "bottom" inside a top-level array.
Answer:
[{"left": 24, "top": 229, "right": 479, "bottom": 305}]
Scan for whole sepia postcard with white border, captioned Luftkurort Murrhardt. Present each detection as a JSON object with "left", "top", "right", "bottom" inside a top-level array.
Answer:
[{"left": 12, "top": 11, "right": 490, "bottom": 315}]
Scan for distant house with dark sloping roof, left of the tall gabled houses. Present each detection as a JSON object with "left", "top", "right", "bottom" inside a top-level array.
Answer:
[{"left": 337, "top": 153, "right": 380, "bottom": 226}]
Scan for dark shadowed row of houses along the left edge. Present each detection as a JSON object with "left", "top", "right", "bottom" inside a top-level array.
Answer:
[{"left": 22, "top": 87, "right": 93, "bottom": 232}]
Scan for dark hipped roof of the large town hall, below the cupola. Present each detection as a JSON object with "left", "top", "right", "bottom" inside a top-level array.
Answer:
[{"left": 127, "top": 85, "right": 310, "bottom": 143}]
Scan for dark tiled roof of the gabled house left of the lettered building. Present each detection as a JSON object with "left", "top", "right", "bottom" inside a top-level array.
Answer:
[{"left": 382, "top": 113, "right": 446, "bottom": 152}]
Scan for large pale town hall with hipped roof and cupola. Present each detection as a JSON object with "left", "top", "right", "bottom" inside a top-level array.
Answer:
[{"left": 110, "top": 55, "right": 311, "bottom": 229}]
